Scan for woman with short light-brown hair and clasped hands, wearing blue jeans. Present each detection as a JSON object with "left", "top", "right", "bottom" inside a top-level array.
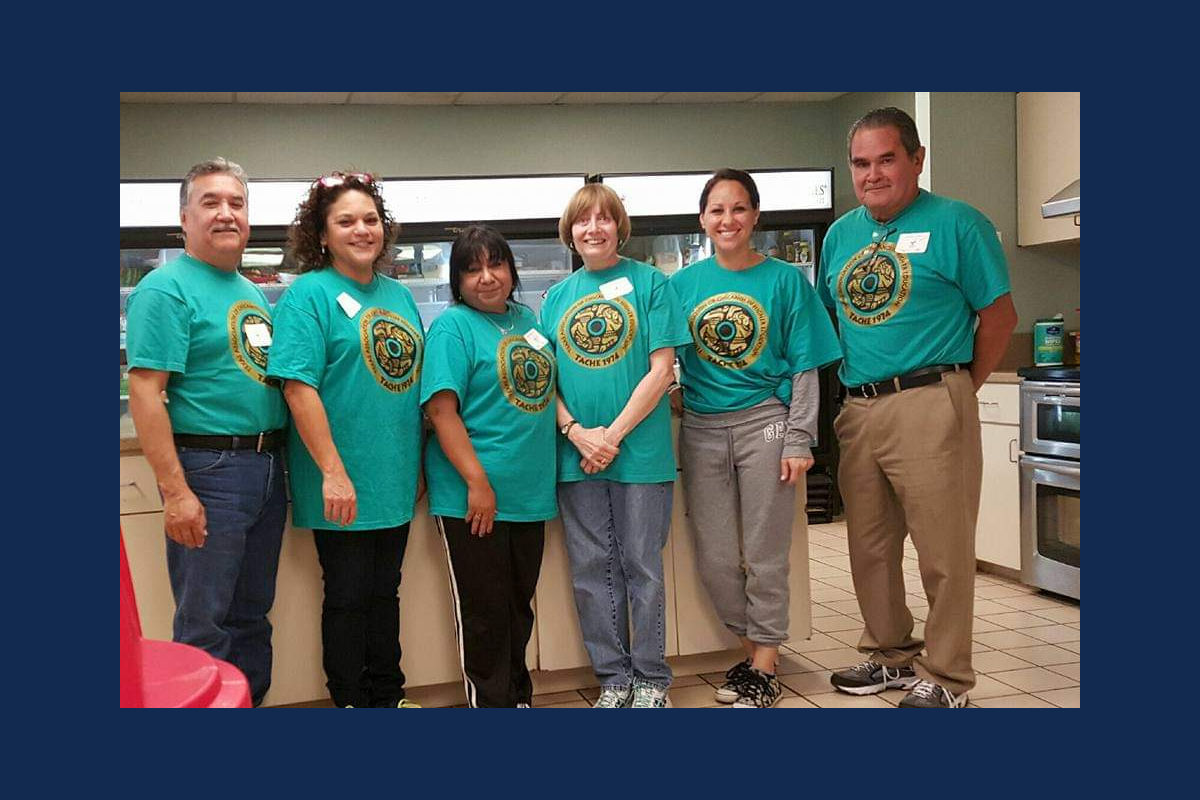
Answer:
[{"left": 541, "top": 184, "right": 690, "bottom": 709}]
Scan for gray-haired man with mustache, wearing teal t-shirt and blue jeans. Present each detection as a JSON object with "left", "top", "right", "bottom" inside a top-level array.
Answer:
[{"left": 126, "top": 158, "right": 287, "bottom": 706}]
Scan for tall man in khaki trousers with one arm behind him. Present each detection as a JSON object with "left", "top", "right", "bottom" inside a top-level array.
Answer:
[{"left": 817, "top": 108, "right": 1016, "bottom": 708}]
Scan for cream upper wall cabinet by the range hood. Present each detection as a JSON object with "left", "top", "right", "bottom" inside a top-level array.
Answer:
[{"left": 1016, "top": 91, "right": 1079, "bottom": 246}]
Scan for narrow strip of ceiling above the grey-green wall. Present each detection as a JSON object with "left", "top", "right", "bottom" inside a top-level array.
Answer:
[{"left": 114, "top": 91, "right": 846, "bottom": 106}]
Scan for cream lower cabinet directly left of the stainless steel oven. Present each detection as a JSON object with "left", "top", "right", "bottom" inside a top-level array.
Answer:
[{"left": 976, "top": 384, "right": 1021, "bottom": 571}]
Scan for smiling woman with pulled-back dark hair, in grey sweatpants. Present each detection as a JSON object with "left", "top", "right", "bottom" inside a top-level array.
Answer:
[{"left": 671, "top": 169, "right": 841, "bottom": 708}]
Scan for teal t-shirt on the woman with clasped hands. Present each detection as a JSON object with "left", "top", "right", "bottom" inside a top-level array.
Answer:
[{"left": 541, "top": 258, "right": 691, "bottom": 483}]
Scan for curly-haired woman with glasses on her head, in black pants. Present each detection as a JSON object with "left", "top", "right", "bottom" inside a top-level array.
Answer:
[{"left": 266, "top": 172, "right": 425, "bottom": 709}]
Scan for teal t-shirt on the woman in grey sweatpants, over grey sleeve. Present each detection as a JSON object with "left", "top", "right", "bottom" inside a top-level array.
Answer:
[{"left": 671, "top": 255, "right": 841, "bottom": 414}]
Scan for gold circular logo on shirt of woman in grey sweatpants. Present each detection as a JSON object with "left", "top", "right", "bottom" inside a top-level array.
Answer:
[{"left": 688, "top": 291, "right": 769, "bottom": 369}]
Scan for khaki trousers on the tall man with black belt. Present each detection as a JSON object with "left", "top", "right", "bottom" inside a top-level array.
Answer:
[{"left": 834, "top": 371, "right": 983, "bottom": 694}]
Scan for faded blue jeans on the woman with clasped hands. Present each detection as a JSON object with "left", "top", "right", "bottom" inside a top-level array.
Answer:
[{"left": 558, "top": 481, "right": 674, "bottom": 688}]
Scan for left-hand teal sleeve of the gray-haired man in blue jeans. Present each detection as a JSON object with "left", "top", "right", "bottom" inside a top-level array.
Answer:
[{"left": 125, "top": 288, "right": 192, "bottom": 373}]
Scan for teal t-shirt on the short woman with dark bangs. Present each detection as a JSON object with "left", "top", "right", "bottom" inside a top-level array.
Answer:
[{"left": 421, "top": 301, "right": 558, "bottom": 522}]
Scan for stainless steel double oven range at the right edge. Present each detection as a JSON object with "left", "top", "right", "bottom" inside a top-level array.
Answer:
[{"left": 1018, "top": 367, "right": 1080, "bottom": 600}]
